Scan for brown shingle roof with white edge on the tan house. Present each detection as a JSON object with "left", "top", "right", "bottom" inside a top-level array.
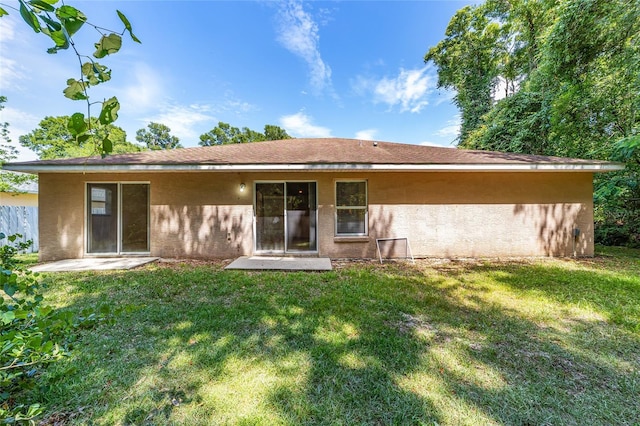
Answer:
[{"left": 5, "top": 138, "right": 621, "bottom": 172}]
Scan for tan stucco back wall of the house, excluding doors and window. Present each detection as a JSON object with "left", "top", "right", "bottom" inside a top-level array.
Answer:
[{"left": 39, "top": 172, "right": 593, "bottom": 260}]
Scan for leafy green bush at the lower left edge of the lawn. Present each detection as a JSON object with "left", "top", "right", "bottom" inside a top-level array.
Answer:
[{"left": 0, "top": 233, "right": 109, "bottom": 424}]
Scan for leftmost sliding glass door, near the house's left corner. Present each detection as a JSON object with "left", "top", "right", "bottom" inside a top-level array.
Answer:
[{"left": 87, "top": 183, "right": 149, "bottom": 254}]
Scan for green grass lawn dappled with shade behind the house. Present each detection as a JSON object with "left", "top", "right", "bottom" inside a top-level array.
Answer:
[{"left": 25, "top": 248, "right": 640, "bottom": 425}]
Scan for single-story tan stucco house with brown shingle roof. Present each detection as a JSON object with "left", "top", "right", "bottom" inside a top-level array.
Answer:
[{"left": 5, "top": 138, "right": 623, "bottom": 261}]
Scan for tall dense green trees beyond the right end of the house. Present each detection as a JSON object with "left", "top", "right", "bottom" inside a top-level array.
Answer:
[{"left": 425, "top": 0, "right": 640, "bottom": 247}]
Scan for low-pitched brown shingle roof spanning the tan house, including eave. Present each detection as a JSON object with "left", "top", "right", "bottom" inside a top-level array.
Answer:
[{"left": 4, "top": 138, "right": 624, "bottom": 173}]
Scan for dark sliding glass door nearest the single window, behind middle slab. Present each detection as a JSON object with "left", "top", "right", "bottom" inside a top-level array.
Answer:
[{"left": 255, "top": 182, "right": 318, "bottom": 253}]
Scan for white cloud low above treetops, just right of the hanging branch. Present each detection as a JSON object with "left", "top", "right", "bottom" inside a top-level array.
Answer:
[{"left": 140, "top": 104, "right": 214, "bottom": 141}]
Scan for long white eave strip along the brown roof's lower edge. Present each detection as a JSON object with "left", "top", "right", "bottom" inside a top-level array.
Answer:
[{"left": 3, "top": 162, "right": 625, "bottom": 174}]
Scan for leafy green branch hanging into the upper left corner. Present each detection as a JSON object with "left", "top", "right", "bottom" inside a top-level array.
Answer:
[{"left": 0, "top": 0, "right": 140, "bottom": 155}]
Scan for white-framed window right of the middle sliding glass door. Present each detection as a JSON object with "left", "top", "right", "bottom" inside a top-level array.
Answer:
[{"left": 336, "top": 180, "right": 368, "bottom": 235}]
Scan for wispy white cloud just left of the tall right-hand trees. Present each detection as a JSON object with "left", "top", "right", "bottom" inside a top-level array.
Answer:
[{"left": 352, "top": 66, "right": 437, "bottom": 113}]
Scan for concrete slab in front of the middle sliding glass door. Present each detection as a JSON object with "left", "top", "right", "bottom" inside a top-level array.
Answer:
[{"left": 225, "top": 256, "right": 332, "bottom": 271}]
